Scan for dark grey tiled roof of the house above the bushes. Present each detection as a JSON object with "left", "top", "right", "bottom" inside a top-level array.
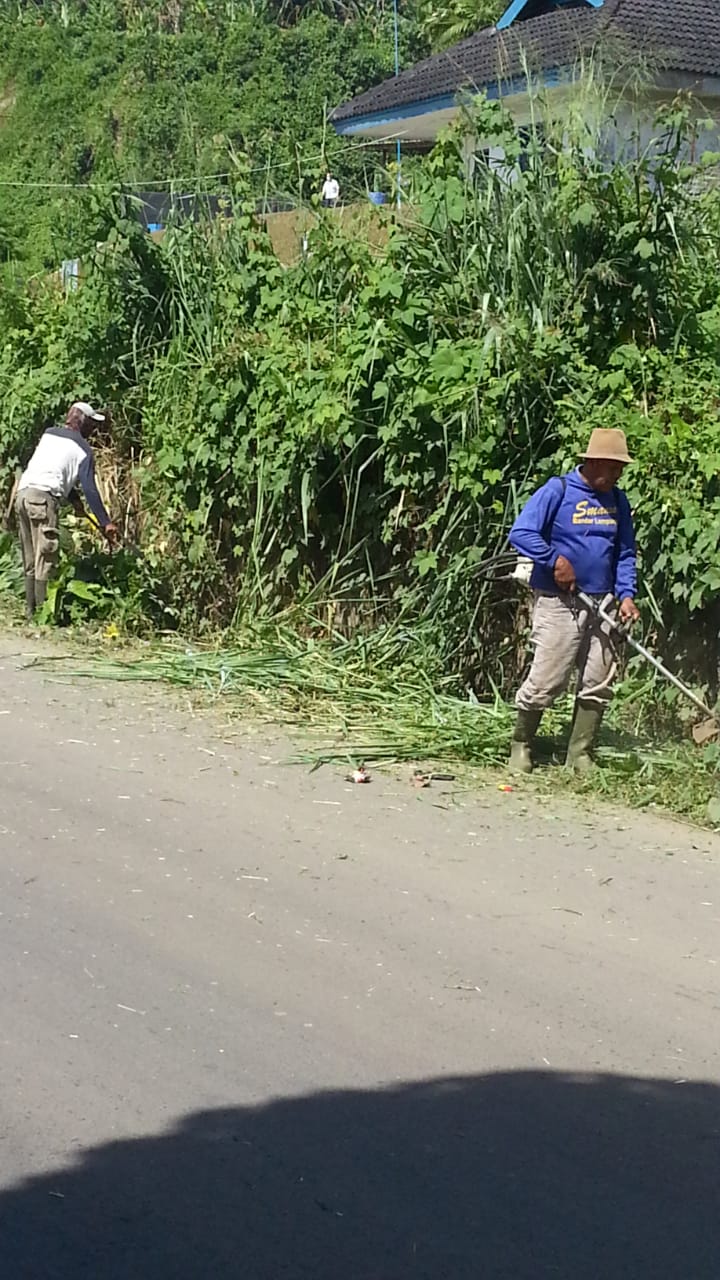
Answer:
[{"left": 331, "top": 0, "right": 720, "bottom": 123}]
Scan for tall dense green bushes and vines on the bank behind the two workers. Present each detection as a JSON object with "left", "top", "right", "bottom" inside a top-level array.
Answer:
[{"left": 0, "top": 93, "right": 720, "bottom": 687}]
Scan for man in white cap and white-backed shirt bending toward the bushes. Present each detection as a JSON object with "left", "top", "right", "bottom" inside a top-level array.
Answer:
[{"left": 15, "top": 401, "right": 115, "bottom": 618}]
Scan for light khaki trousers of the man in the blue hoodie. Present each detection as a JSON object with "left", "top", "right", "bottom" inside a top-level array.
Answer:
[{"left": 515, "top": 591, "right": 618, "bottom": 712}]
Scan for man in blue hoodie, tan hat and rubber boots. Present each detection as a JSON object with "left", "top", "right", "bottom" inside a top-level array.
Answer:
[{"left": 510, "top": 429, "right": 639, "bottom": 773}]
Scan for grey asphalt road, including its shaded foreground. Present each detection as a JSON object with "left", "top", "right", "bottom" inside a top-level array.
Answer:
[{"left": 0, "top": 639, "right": 720, "bottom": 1280}]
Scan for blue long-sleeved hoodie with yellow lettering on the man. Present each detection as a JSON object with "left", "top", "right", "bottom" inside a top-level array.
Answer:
[{"left": 510, "top": 468, "right": 637, "bottom": 600}]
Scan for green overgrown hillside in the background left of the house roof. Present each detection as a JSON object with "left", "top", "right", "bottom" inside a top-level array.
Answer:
[{"left": 0, "top": 0, "right": 427, "bottom": 267}]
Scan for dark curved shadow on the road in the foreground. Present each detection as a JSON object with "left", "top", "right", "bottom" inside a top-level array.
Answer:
[{"left": 0, "top": 1073, "right": 720, "bottom": 1280}]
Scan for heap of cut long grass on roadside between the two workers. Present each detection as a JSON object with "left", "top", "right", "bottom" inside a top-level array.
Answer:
[{"left": 33, "top": 627, "right": 512, "bottom": 765}]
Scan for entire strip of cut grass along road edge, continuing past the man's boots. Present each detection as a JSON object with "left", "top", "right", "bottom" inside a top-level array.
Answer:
[{"left": 28, "top": 614, "right": 720, "bottom": 826}]
